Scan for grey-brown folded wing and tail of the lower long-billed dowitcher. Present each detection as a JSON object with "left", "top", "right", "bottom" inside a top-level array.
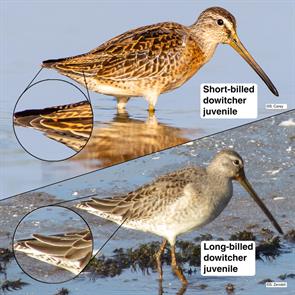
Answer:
[{"left": 77, "top": 167, "right": 205, "bottom": 221}]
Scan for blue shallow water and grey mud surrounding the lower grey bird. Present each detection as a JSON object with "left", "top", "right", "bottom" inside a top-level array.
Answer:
[{"left": 0, "top": 111, "right": 295, "bottom": 295}]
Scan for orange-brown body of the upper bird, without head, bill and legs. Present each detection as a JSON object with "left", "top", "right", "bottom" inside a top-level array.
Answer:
[{"left": 43, "top": 22, "right": 204, "bottom": 96}]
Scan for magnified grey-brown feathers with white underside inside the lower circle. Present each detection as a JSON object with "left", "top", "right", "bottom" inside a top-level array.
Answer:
[{"left": 13, "top": 230, "right": 93, "bottom": 275}]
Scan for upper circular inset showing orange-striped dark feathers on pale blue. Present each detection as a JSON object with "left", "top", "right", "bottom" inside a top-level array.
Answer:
[{"left": 13, "top": 79, "right": 93, "bottom": 161}]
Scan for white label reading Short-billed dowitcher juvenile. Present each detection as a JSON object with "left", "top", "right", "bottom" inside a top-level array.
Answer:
[{"left": 200, "top": 83, "right": 258, "bottom": 119}]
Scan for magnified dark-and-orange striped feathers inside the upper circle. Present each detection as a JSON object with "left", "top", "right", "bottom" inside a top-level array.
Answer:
[{"left": 13, "top": 101, "right": 93, "bottom": 152}]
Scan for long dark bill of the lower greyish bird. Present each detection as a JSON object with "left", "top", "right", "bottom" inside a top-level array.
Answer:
[{"left": 237, "top": 172, "right": 284, "bottom": 234}]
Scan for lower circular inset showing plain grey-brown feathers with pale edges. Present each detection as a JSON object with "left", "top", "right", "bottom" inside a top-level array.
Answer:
[{"left": 13, "top": 206, "right": 93, "bottom": 283}]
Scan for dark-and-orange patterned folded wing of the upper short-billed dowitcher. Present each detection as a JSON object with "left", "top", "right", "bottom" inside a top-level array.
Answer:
[{"left": 44, "top": 22, "right": 199, "bottom": 80}]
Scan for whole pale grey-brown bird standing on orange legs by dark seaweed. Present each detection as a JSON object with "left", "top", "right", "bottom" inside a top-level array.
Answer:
[{"left": 77, "top": 150, "right": 283, "bottom": 284}]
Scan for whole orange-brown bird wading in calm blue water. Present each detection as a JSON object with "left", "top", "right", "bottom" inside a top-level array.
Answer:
[{"left": 43, "top": 7, "right": 279, "bottom": 111}]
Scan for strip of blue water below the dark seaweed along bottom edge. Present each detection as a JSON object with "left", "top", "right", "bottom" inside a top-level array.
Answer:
[{"left": 3, "top": 249, "right": 295, "bottom": 295}]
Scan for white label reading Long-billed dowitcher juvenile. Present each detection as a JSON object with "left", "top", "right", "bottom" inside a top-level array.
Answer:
[{"left": 201, "top": 241, "right": 256, "bottom": 276}]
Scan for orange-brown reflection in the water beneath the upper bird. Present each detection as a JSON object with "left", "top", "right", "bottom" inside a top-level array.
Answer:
[{"left": 71, "top": 111, "right": 200, "bottom": 168}]
